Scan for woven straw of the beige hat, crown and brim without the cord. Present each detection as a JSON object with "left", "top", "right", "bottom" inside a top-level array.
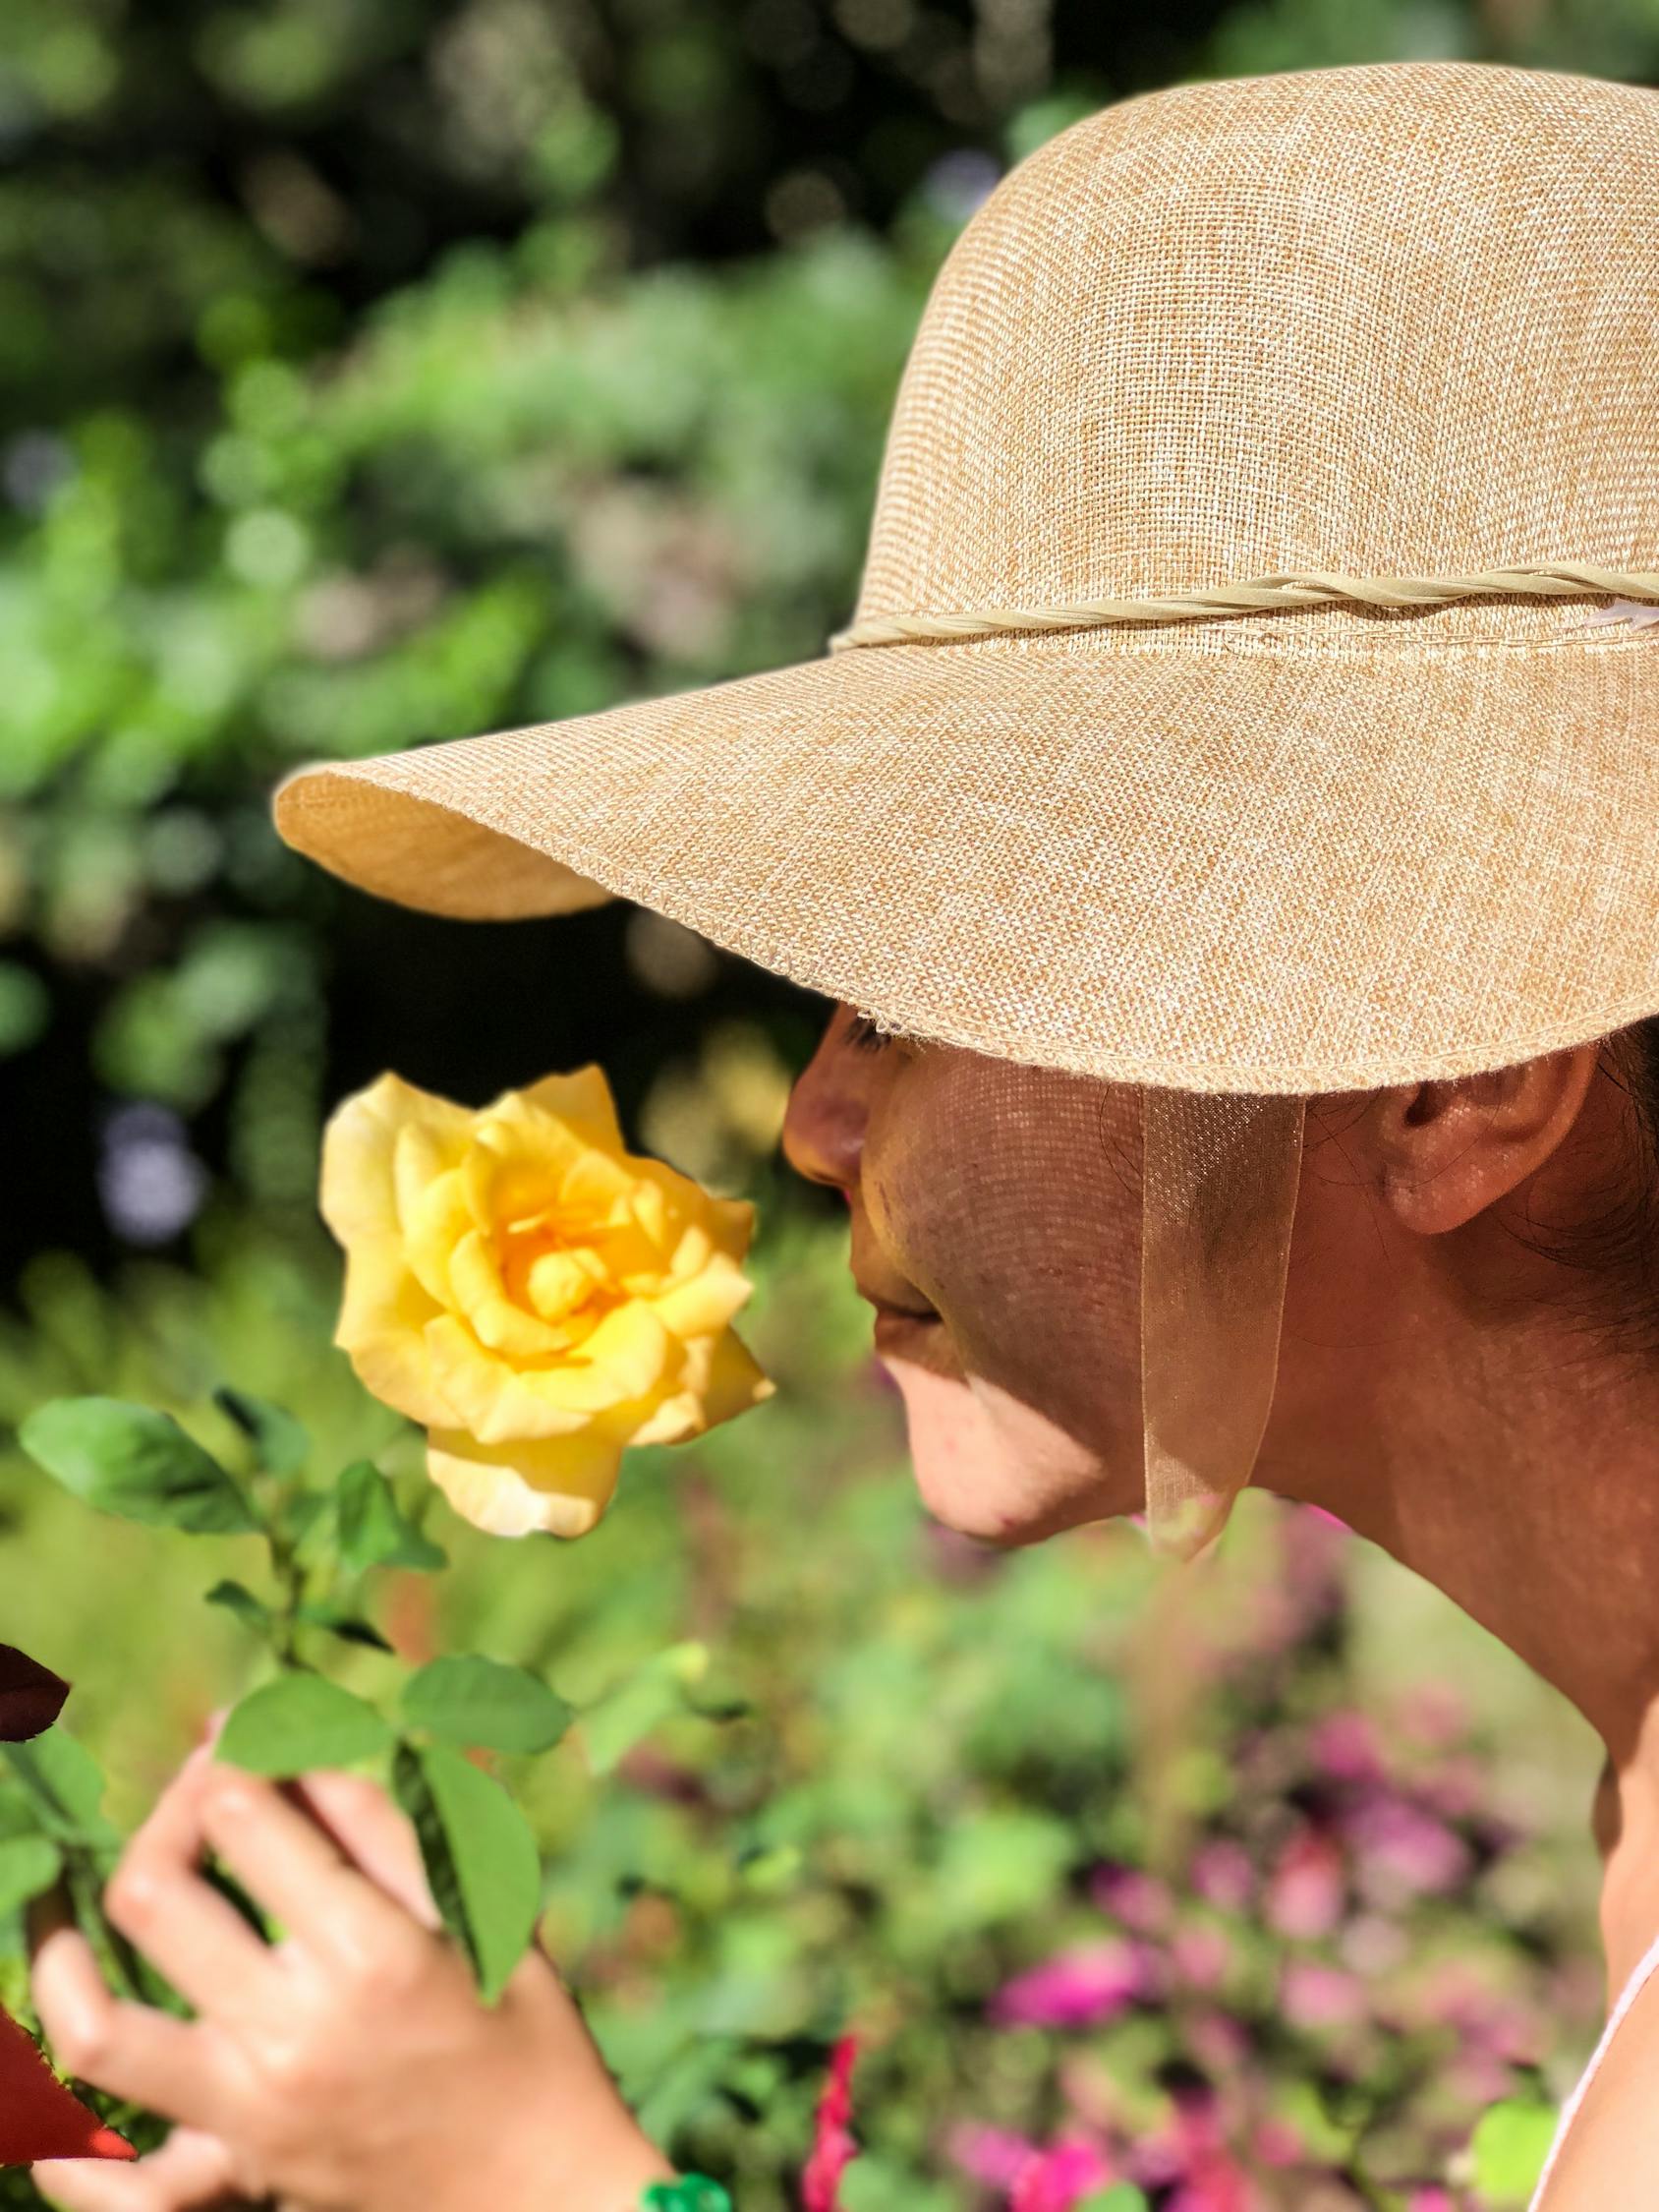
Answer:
[{"left": 276, "top": 62, "right": 1659, "bottom": 1093}]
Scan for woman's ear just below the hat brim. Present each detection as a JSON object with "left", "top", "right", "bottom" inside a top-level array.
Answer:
[{"left": 1376, "top": 1044, "right": 1599, "bottom": 1237}]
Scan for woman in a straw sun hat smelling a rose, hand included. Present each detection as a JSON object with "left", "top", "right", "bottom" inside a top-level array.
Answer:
[{"left": 37, "top": 64, "right": 1659, "bottom": 2212}]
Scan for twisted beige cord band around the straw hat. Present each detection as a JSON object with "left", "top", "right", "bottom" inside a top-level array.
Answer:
[{"left": 830, "top": 562, "right": 1659, "bottom": 653}]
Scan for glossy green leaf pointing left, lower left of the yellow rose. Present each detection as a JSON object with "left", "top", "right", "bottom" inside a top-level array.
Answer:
[{"left": 18, "top": 1398, "right": 258, "bottom": 1536}]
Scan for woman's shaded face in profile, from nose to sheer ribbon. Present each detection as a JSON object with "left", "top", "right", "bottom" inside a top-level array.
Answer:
[{"left": 783, "top": 1005, "right": 1141, "bottom": 1544}]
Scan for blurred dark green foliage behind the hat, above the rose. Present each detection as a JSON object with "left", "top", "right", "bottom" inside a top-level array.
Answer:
[{"left": 0, "top": 0, "right": 1659, "bottom": 1267}]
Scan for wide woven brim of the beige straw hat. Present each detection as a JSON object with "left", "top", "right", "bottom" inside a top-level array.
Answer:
[{"left": 276, "top": 628, "right": 1659, "bottom": 1093}]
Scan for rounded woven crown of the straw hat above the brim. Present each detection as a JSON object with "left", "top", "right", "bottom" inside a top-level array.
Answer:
[{"left": 858, "top": 62, "right": 1659, "bottom": 653}]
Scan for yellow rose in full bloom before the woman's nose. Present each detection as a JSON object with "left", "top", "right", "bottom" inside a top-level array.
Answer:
[{"left": 320, "top": 1067, "right": 774, "bottom": 1538}]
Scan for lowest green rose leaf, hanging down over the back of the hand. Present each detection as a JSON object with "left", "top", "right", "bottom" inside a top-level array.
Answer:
[{"left": 391, "top": 1743, "right": 542, "bottom": 2005}]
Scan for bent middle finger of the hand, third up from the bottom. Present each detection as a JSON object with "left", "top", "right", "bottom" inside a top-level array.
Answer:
[{"left": 104, "top": 1752, "right": 279, "bottom": 2022}]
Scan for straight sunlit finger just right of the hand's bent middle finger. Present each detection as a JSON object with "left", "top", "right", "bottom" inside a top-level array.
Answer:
[{"left": 201, "top": 1766, "right": 429, "bottom": 1964}]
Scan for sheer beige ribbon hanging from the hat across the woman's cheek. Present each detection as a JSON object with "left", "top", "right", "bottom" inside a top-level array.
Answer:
[{"left": 1141, "top": 1086, "right": 1305, "bottom": 1559}]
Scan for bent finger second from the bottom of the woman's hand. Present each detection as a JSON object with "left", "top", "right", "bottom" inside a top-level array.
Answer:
[{"left": 31, "top": 1929, "right": 221, "bottom": 2132}]
